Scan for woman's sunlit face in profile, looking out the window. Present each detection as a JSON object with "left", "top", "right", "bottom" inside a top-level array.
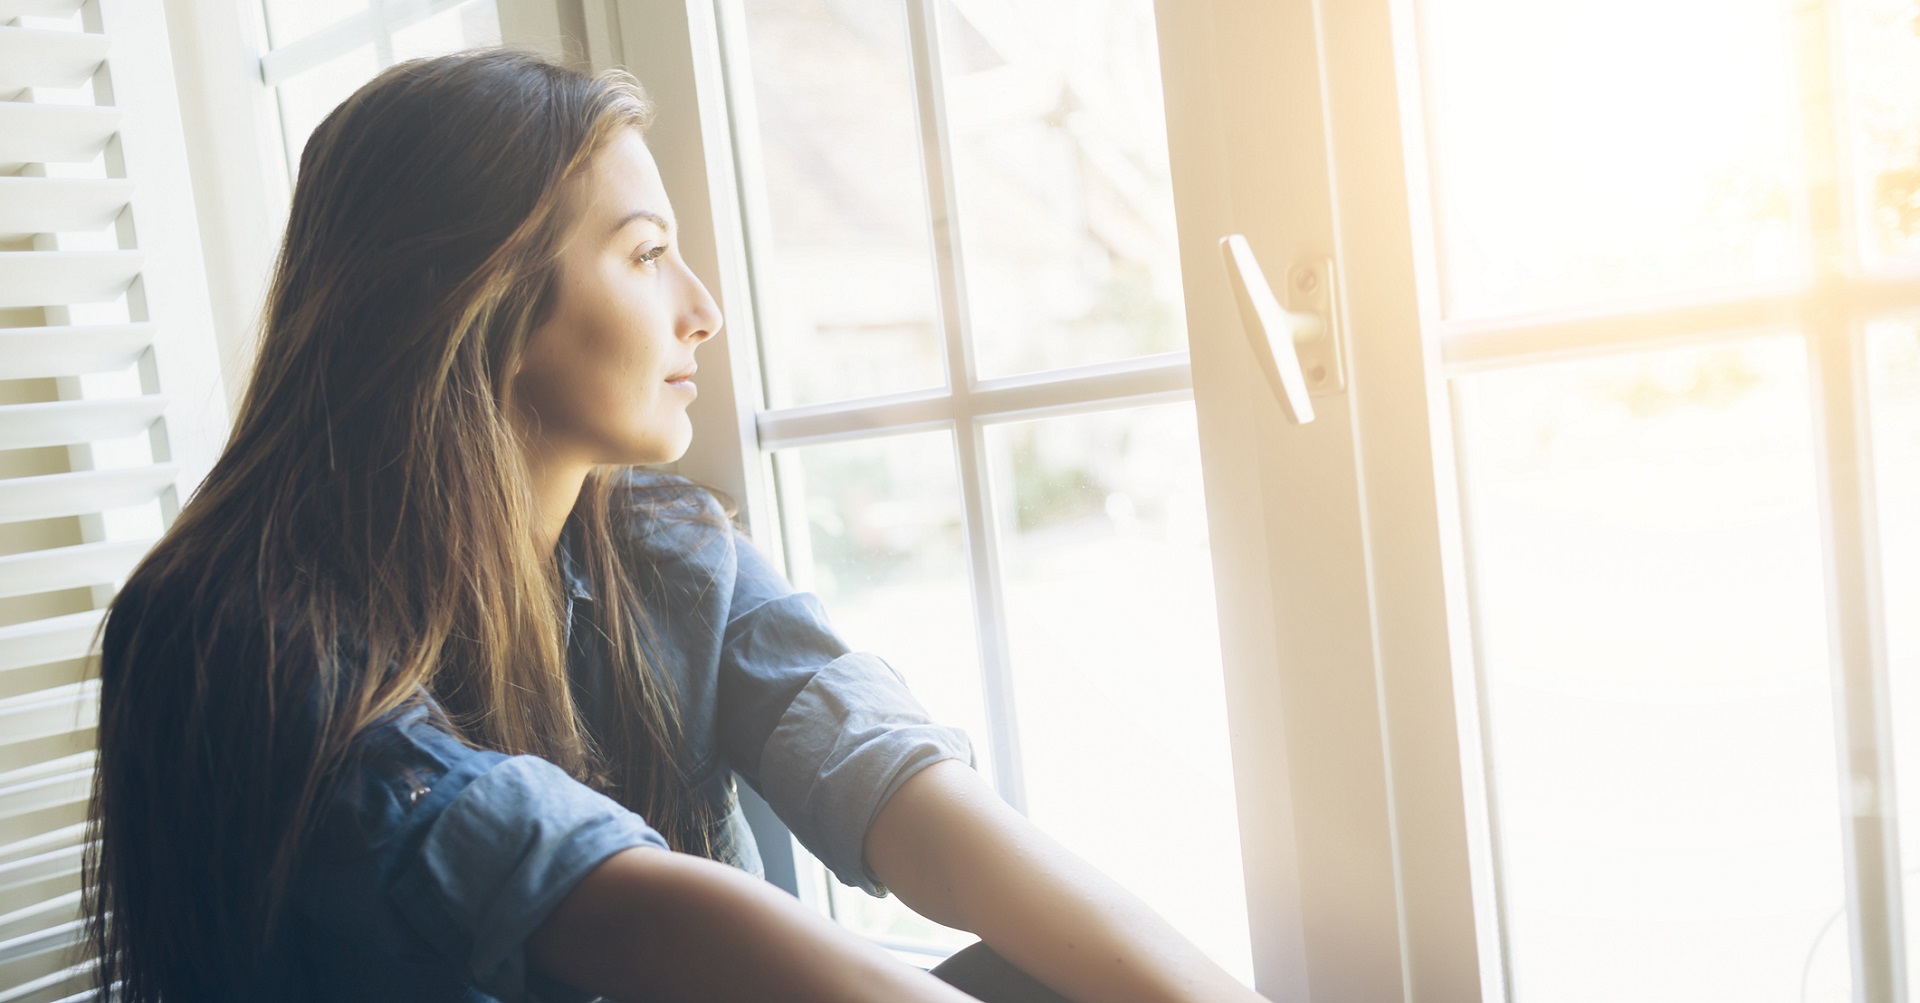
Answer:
[{"left": 509, "top": 129, "right": 720, "bottom": 465}]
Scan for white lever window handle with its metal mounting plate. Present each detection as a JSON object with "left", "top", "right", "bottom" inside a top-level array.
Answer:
[{"left": 1219, "top": 234, "right": 1346, "bottom": 425}]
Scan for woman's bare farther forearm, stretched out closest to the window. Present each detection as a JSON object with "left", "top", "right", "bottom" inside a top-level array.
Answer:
[{"left": 866, "top": 761, "right": 1260, "bottom": 1003}]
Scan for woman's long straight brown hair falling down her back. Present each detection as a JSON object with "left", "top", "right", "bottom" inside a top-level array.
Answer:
[{"left": 86, "top": 50, "right": 714, "bottom": 1003}]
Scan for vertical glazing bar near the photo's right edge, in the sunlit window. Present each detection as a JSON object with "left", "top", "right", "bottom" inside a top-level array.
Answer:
[{"left": 1793, "top": 2, "right": 1907, "bottom": 1003}]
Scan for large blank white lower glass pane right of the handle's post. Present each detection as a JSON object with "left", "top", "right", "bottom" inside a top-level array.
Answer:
[{"left": 1455, "top": 336, "right": 1851, "bottom": 1003}]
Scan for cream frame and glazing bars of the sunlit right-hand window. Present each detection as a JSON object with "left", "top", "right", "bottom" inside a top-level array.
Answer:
[{"left": 1160, "top": 0, "right": 1920, "bottom": 1003}]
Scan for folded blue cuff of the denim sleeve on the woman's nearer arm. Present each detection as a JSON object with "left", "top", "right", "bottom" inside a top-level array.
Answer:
[{"left": 385, "top": 755, "right": 666, "bottom": 1003}]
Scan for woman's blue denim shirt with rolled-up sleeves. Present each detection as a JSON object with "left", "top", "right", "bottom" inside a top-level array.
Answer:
[{"left": 261, "top": 473, "right": 972, "bottom": 1003}]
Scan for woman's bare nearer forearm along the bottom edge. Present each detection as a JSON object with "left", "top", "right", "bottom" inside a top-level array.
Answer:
[{"left": 526, "top": 849, "right": 972, "bottom": 1003}]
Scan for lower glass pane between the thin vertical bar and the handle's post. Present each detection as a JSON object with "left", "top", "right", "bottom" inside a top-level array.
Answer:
[{"left": 987, "top": 404, "right": 1252, "bottom": 980}]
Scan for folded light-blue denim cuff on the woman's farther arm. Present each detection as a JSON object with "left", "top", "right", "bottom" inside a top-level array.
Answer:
[{"left": 760, "top": 653, "right": 973, "bottom": 895}]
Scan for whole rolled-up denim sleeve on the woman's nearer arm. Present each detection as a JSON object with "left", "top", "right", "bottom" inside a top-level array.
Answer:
[{"left": 309, "top": 711, "right": 666, "bottom": 1003}]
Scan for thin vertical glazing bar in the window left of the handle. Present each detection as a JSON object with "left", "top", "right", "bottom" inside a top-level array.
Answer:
[{"left": 906, "top": 0, "right": 1027, "bottom": 813}]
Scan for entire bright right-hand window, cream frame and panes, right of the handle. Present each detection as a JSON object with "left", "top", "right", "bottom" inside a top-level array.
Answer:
[{"left": 1164, "top": 0, "right": 1920, "bottom": 1001}]
